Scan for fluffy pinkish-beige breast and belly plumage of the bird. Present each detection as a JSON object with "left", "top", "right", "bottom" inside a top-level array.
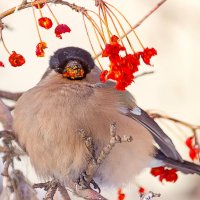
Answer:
[{"left": 14, "top": 69, "right": 153, "bottom": 184}]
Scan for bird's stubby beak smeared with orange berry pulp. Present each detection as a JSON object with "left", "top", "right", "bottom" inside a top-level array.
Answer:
[{"left": 63, "top": 61, "right": 85, "bottom": 80}]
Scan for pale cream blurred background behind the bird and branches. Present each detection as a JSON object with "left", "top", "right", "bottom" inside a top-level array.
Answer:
[{"left": 0, "top": 0, "right": 200, "bottom": 200}]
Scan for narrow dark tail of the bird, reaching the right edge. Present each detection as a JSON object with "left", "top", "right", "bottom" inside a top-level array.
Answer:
[{"left": 155, "top": 150, "right": 200, "bottom": 175}]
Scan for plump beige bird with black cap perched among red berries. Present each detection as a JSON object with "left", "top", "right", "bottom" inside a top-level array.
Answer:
[{"left": 13, "top": 46, "right": 200, "bottom": 187}]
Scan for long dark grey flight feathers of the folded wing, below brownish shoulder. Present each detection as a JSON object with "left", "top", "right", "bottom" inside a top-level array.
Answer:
[{"left": 127, "top": 107, "right": 183, "bottom": 162}]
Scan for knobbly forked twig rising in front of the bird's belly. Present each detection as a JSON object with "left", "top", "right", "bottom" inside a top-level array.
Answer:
[{"left": 74, "top": 123, "right": 133, "bottom": 200}]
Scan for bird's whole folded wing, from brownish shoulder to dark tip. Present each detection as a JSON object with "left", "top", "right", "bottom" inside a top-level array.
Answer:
[{"left": 93, "top": 82, "right": 183, "bottom": 162}]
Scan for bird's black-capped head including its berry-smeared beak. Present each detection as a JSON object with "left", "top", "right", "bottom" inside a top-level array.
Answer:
[{"left": 50, "top": 47, "right": 95, "bottom": 80}]
